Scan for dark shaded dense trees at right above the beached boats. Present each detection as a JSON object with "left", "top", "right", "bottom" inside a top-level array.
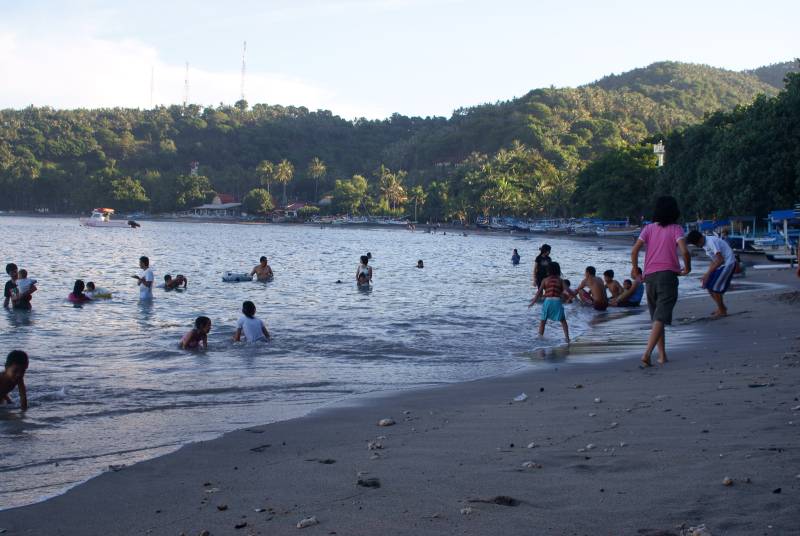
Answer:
[{"left": 574, "top": 73, "right": 800, "bottom": 219}]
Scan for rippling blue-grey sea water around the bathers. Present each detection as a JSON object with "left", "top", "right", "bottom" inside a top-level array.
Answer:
[{"left": 0, "top": 217, "right": 648, "bottom": 508}]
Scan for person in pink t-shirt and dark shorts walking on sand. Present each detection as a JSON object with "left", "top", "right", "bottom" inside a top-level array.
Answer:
[{"left": 631, "top": 196, "right": 692, "bottom": 367}]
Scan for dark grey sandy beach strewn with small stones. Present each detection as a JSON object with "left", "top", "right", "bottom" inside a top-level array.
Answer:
[{"left": 0, "top": 270, "right": 800, "bottom": 536}]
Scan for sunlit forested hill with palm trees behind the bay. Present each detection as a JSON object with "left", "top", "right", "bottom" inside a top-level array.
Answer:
[{"left": 0, "top": 58, "right": 792, "bottom": 219}]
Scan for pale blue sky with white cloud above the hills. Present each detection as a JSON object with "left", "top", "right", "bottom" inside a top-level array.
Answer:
[{"left": 0, "top": 0, "right": 800, "bottom": 119}]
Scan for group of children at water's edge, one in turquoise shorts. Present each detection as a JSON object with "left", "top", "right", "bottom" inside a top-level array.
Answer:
[{"left": 524, "top": 244, "right": 644, "bottom": 342}]
